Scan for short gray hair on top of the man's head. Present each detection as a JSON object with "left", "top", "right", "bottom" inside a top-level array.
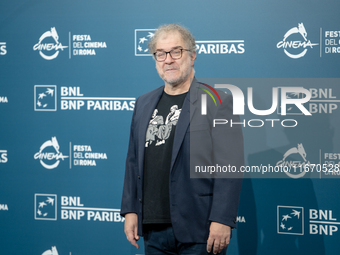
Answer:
[{"left": 148, "top": 24, "right": 196, "bottom": 54}]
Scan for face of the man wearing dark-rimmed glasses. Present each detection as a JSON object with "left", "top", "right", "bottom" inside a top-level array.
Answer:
[{"left": 156, "top": 32, "right": 196, "bottom": 86}]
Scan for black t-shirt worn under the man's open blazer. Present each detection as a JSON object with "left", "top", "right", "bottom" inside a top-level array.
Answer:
[{"left": 143, "top": 92, "right": 187, "bottom": 224}]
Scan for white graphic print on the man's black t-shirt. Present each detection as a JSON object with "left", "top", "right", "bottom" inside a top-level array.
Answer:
[{"left": 145, "top": 105, "right": 182, "bottom": 147}]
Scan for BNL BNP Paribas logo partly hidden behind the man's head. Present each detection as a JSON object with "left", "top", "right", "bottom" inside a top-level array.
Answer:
[{"left": 135, "top": 29, "right": 245, "bottom": 56}]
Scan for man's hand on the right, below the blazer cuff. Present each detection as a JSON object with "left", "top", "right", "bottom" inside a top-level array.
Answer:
[{"left": 207, "top": 221, "right": 231, "bottom": 254}]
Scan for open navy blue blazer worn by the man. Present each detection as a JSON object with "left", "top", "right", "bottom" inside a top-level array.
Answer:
[{"left": 121, "top": 79, "right": 244, "bottom": 243}]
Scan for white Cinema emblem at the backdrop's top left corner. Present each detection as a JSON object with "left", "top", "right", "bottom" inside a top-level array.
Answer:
[{"left": 33, "top": 27, "right": 68, "bottom": 60}]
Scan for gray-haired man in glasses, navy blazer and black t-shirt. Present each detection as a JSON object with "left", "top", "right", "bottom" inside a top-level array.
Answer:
[{"left": 121, "top": 24, "right": 243, "bottom": 255}]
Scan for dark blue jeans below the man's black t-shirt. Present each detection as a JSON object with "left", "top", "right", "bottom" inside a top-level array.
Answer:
[{"left": 144, "top": 224, "right": 227, "bottom": 255}]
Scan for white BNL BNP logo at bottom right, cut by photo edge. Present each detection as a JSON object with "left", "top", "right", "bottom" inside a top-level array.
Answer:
[{"left": 277, "top": 205, "right": 340, "bottom": 236}]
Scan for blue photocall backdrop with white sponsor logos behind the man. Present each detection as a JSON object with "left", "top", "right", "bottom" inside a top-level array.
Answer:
[{"left": 0, "top": 0, "right": 340, "bottom": 255}]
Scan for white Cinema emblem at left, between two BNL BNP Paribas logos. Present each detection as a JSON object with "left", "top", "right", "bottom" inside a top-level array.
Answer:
[{"left": 34, "top": 137, "right": 68, "bottom": 169}]
